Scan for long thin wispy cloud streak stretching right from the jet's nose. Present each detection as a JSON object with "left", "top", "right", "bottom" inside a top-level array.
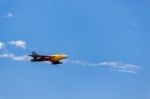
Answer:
[{"left": 65, "top": 60, "right": 140, "bottom": 73}]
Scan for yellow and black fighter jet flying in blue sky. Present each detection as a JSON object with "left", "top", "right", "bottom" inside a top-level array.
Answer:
[{"left": 29, "top": 52, "right": 68, "bottom": 64}]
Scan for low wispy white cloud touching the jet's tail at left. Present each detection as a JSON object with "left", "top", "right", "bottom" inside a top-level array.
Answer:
[{"left": 0, "top": 53, "right": 30, "bottom": 61}]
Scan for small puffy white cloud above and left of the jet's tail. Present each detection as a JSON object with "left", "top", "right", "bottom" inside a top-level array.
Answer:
[{"left": 9, "top": 40, "right": 26, "bottom": 48}]
